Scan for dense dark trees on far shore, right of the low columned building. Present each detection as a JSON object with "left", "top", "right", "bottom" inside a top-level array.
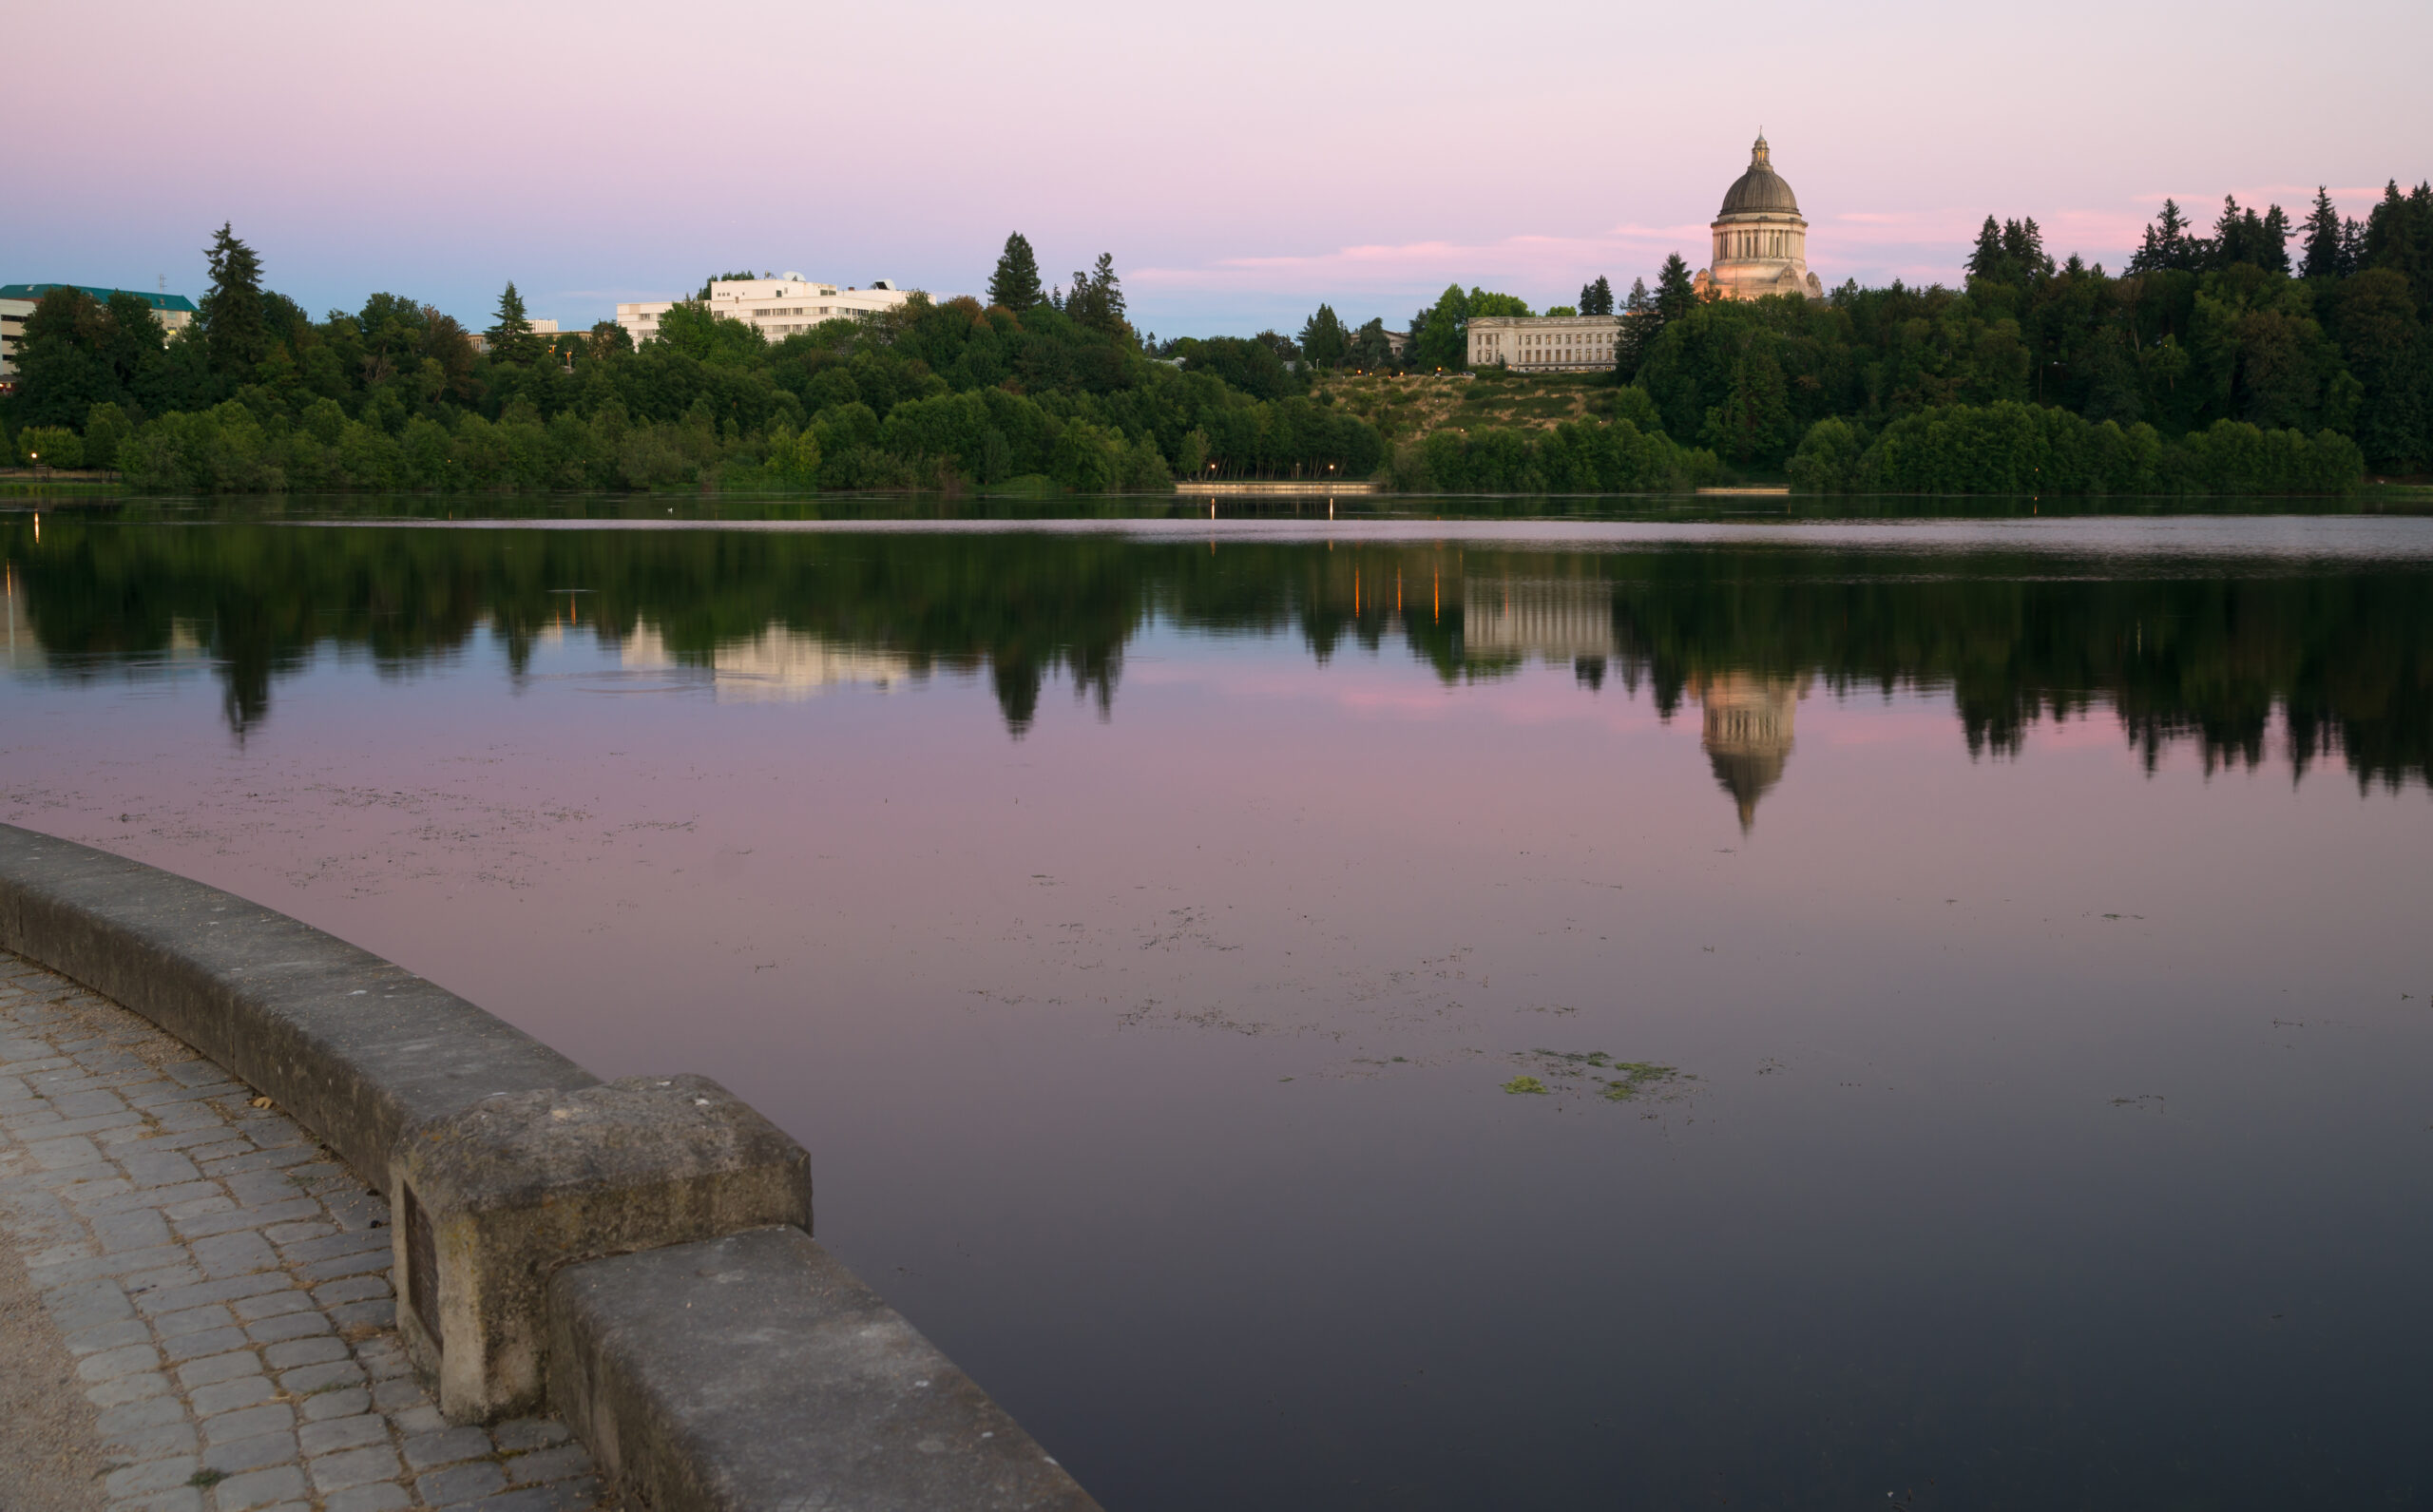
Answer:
[{"left": 1620, "top": 182, "right": 2433, "bottom": 492}]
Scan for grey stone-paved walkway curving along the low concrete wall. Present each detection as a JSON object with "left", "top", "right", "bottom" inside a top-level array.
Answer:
[{"left": 0, "top": 952, "right": 603, "bottom": 1512}]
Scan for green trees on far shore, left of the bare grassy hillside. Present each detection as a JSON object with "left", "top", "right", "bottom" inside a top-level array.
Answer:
[{"left": 0, "top": 226, "right": 1385, "bottom": 492}]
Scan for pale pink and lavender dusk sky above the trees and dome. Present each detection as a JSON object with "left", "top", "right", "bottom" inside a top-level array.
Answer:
[{"left": 19, "top": 0, "right": 2433, "bottom": 336}]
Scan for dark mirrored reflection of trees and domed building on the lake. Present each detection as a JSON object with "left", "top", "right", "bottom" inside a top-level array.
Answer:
[{"left": 0, "top": 516, "right": 2433, "bottom": 803}]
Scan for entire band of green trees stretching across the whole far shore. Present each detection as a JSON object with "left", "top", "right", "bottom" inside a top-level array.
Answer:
[{"left": 0, "top": 182, "right": 2433, "bottom": 494}]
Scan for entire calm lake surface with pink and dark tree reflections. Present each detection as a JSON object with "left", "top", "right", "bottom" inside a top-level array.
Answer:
[{"left": 0, "top": 504, "right": 2433, "bottom": 1512}]
